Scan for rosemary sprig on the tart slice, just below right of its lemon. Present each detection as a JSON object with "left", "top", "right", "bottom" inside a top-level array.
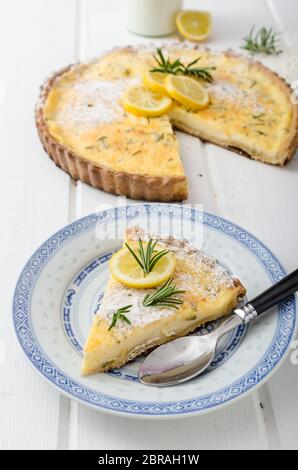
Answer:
[{"left": 143, "top": 279, "right": 185, "bottom": 309}]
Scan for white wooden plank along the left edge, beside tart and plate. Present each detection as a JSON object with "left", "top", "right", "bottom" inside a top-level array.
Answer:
[{"left": 0, "top": 0, "right": 75, "bottom": 449}]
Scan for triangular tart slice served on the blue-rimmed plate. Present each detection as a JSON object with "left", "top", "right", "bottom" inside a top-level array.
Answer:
[{"left": 82, "top": 227, "right": 245, "bottom": 375}]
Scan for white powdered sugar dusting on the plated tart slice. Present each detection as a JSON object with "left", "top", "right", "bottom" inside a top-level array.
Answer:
[{"left": 99, "top": 227, "right": 240, "bottom": 331}]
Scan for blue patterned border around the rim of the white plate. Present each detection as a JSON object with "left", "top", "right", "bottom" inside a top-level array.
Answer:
[{"left": 13, "top": 204, "right": 296, "bottom": 416}]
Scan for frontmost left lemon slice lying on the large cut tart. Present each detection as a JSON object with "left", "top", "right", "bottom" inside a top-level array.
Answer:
[{"left": 122, "top": 85, "right": 172, "bottom": 117}]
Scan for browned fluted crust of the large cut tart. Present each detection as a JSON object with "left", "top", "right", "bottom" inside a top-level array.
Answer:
[{"left": 35, "top": 46, "right": 298, "bottom": 202}]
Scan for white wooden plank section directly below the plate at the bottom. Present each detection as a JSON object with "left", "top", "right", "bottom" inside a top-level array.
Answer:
[{"left": 73, "top": 399, "right": 267, "bottom": 450}]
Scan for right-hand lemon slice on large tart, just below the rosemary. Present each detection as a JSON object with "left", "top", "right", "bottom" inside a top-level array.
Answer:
[{"left": 165, "top": 75, "right": 209, "bottom": 110}]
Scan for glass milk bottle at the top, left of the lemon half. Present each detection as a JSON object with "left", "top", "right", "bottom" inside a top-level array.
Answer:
[{"left": 125, "top": 0, "right": 183, "bottom": 36}]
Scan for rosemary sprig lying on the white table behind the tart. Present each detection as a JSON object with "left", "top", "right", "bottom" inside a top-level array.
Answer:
[{"left": 241, "top": 26, "right": 282, "bottom": 55}]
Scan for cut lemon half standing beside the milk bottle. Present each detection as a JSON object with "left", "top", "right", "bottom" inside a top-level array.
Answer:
[{"left": 176, "top": 10, "right": 212, "bottom": 41}]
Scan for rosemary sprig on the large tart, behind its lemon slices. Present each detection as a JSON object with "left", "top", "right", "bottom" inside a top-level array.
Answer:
[{"left": 150, "top": 48, "right": 216, "bottom": 82}]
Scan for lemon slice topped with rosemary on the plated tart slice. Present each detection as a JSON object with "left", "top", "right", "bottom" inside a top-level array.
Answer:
[{"left": 109, "top": 244, "right": 176, "bottom": 289}]
